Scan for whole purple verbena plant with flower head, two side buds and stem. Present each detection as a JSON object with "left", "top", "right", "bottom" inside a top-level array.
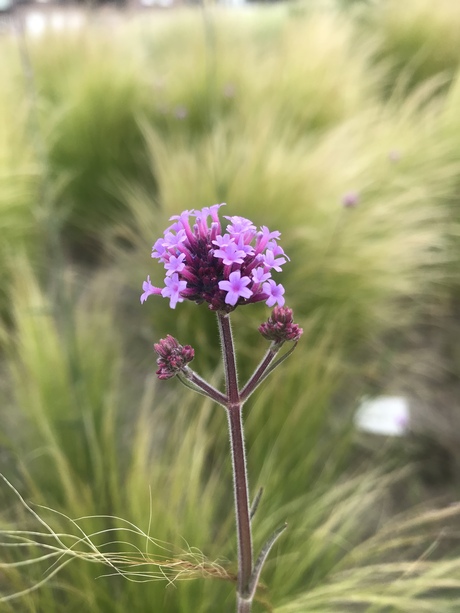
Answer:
[{"left": 141, "top": 204, "right": 303, "bottom": 613}]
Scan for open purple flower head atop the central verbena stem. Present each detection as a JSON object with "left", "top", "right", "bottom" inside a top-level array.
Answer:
[{"left": 141, "top": 204, "right": 289, "bottom": 313}]
